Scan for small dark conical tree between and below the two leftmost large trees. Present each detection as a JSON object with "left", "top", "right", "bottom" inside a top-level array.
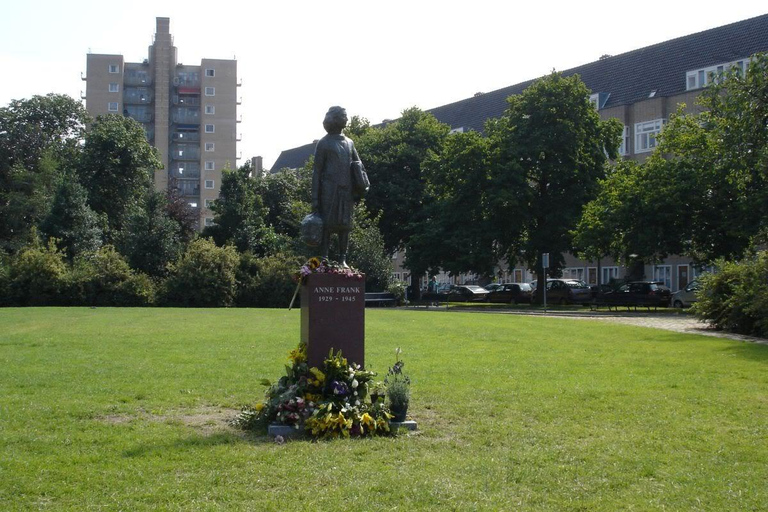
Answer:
[{"left": 40, "top": 179, "right": 103, "bottom": 261}]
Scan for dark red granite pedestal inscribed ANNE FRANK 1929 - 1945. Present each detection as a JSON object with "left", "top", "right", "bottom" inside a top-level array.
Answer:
[{"left": 301, "top": 273, "right": 365, "bottom": 368}]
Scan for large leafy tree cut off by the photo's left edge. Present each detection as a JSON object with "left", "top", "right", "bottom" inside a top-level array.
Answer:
[{"left": 0, "top": 94, "right": 88, "bottom": 251}]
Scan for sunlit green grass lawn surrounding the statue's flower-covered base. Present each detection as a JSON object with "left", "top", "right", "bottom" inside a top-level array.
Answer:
[{"left": 0, "top": 308, "right": 768, "bottom": 511}]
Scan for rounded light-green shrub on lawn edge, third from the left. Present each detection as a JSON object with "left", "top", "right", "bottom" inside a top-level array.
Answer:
[{"left": 161, "top": 238, "right": 239, "bottom": 307}]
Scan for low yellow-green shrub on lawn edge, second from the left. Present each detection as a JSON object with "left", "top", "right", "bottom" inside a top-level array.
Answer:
[{"left": 66, "top": 246, "right": 155, "bottom": 306}]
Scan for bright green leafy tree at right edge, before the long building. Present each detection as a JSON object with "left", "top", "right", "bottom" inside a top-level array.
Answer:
[{"left": 576, "top": 55, "right": 768, "bottom": 263}]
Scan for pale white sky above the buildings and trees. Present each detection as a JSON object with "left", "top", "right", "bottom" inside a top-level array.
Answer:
[{"left": 0, "top": 0, "right": 768, "bottom": 169}]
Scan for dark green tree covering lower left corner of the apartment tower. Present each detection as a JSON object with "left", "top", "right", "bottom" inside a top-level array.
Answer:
[{"left": 77, "top": 114, "right": 162, "bottom": 231}]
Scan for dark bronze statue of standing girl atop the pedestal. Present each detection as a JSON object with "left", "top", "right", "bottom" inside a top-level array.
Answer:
[{"left": 312, "top": 107, "right": 369, "bottom": 266}]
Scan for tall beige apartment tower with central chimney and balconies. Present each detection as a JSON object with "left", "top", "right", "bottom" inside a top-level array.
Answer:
[{"left": 83, "top": 18, "right": 240, "bottom": 228}]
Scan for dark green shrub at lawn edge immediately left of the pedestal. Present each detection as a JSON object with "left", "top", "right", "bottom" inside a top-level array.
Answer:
[{"left": 236, "top": 252, "right": 302, "bottom": 308}]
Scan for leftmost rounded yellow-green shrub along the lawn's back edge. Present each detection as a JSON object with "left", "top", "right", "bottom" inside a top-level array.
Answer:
[{"left": 8, "top": 239, "right": 69, "bottom": 306}]
